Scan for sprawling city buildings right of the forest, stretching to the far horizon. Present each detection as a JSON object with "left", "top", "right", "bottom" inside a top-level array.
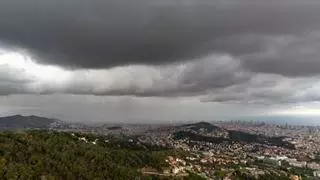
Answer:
[{"left": 55, "top": 122, "right": 320, "bottom": 179}]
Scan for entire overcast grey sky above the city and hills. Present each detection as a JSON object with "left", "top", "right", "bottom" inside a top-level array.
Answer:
[{"left": 0, "top": 0, "right": 320, "bottom": 123}]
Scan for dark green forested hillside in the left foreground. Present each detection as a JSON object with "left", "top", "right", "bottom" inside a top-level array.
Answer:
[{"left": 0, "top": 130, "right": 196, "bottom": 180}]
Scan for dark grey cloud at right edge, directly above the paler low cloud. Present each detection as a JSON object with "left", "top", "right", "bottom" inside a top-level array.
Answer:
[{"left": 242, "top": 32, "right": 320, "bottom": 76}]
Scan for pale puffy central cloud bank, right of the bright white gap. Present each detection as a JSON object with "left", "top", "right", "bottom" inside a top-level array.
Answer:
[{"left": 65, "top": 56, "right": 251, "bottom": 97}]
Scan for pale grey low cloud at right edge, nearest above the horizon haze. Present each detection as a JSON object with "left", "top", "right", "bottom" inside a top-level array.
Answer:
[{"left": 202, "top": 75, "right": 320, "bottom": 105}]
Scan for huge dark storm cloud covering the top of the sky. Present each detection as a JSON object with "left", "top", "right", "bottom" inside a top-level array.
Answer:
[{"left": 0, "top": 0, "right": 320, "bottom": 70}]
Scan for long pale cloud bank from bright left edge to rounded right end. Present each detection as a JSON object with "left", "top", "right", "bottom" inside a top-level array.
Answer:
[{"left": 0, "top": 55, "right": 251, "bottom": 97}]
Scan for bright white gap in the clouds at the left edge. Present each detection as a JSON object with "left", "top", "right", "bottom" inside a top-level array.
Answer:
[{"left": 0, "top": 52, "right": 70, "bottom": 82}]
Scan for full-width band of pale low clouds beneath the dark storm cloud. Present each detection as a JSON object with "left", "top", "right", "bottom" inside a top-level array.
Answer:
[{"left": 0, "top": 52, "right": 320, "bottom": 105}]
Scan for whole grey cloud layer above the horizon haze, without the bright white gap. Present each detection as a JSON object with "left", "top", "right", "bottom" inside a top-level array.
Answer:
[{"left": 0, "top": 0, "right": 320, "bottom": 103}]
